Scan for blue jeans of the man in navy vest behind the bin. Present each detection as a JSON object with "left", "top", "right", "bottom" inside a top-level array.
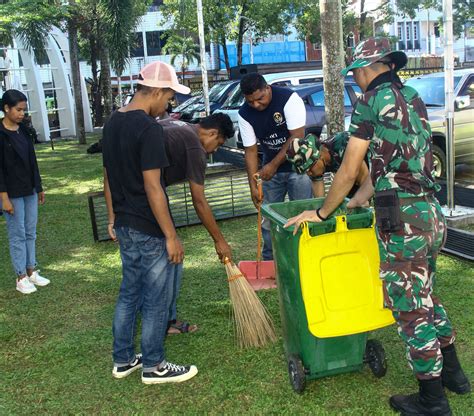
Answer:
[{"left": 262, "top": 172, "right": 313, "bottom": 260}]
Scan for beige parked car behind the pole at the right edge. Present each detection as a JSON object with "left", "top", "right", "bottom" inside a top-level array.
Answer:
[{"left": 406, "top": 68, "right": 474, "bottom": 177}]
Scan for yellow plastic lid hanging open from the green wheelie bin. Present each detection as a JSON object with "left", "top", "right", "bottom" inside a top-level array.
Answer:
[{"left": 299, "top": 215, "right": 394, "bottom": 338}]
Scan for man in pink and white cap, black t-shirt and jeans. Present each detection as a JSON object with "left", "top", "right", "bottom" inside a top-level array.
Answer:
[{"left": 102, "top": 62, "right": 197, "bottom": 384}]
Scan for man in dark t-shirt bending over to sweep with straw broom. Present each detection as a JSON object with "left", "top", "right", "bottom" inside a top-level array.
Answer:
[{"left": 159, "top": 113, "right": 234, "bottom": 333}]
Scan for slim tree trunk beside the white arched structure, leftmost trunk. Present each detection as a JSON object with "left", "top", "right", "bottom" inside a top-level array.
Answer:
[{"left": 68, "top": 0, "right": 86, "bottom": 144}]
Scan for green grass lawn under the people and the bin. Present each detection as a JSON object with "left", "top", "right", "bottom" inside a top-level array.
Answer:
[{"left": 0, "top": 138, "right": 474, "bottom": 415}]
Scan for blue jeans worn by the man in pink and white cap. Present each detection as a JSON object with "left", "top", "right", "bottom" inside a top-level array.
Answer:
[{"left": 113, "top": 227, "right": 177, "bottom": 372}]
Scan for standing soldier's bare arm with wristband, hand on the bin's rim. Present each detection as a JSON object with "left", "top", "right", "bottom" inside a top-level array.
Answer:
[{"left": 285, "top": 137, "right": 370, "bottom": 234}]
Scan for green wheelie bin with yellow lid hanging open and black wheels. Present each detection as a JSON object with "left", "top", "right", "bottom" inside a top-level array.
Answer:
[{"left": 262, "top": 198, "right": 394, "bottom": 393}]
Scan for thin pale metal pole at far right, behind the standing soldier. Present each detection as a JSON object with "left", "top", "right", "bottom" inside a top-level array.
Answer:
[{"left": 443, "top": 0, "right": 455, "bottom": 211}]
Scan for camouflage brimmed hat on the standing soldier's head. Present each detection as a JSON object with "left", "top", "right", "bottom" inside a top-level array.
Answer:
[{"left": 341, "top": 37, "right": 408, "bottom": 76}]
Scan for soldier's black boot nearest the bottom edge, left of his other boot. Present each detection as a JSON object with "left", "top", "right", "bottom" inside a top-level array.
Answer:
[{"left": 390, "top": 377, "right": 452, "bottom": 416}]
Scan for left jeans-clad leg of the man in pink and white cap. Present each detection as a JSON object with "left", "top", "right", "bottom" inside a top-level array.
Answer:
[{"left": 113, "top": 227, "right": 142, "bottom": 367}]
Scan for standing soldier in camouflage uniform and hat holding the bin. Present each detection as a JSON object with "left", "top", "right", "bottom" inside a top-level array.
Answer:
[{"left": 287, "top": 38, "right": 471, "bottom": 415}]
